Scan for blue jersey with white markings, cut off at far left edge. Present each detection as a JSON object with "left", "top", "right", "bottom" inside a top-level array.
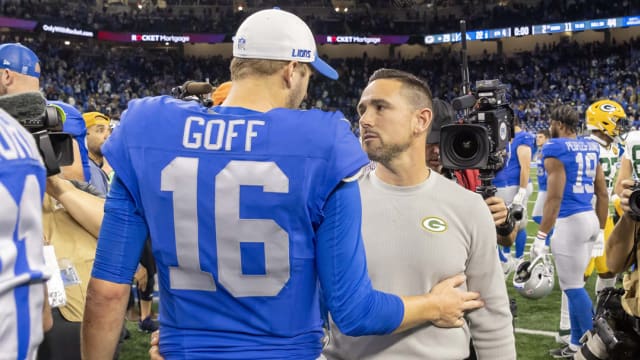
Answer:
[{"left": 0, "top": 109, "right": 46, "bottom": 359}]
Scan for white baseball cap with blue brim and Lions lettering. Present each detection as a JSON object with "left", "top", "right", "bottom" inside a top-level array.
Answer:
[{"left": 233, "top": 9, "right": 338, "bottom": 80}]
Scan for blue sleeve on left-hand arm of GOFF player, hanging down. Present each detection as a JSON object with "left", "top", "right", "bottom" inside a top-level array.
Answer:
[{"left": 91, "top": 175, "right": 149, "bottom": 284}]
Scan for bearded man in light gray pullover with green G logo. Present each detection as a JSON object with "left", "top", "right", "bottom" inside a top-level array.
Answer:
[{"left": 324, "top": 69, "right": 516, "bottom": 360}]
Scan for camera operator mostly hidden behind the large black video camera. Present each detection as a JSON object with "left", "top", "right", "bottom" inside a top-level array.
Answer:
[{"left": 426, "top": 98, "right": 517, "bottom": 246}]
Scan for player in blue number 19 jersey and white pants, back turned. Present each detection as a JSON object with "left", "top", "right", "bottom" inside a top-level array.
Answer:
[{"left": 531, "top": 105, "right": 608, "bottom": 358}]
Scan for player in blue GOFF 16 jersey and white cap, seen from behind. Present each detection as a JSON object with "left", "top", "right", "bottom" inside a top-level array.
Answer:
[{"left": 82, "top": 9, "right": 483, "bottom": 359}]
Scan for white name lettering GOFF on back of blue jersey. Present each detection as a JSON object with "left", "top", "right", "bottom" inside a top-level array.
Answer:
[{"left": 182, "top": 116, "right": 265, "bottom": 152}]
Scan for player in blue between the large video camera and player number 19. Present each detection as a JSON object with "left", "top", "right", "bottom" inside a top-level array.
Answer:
[{"left": 493, "top": 118, "right": 535, "bottom": 263}]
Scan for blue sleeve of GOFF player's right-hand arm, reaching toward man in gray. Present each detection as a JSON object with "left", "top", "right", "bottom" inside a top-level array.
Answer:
[{"left": 316, "top": 182, "right": 404, "bottom": 336}]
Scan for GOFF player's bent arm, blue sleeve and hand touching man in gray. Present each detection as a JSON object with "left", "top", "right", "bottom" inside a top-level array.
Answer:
[{"left": 316, "top": 182, "right": 482, "bottom": 336}]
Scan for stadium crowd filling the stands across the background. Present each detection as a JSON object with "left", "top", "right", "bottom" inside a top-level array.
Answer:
[{"left": 0, "top": 30, "right": 640, "bottom": 132}]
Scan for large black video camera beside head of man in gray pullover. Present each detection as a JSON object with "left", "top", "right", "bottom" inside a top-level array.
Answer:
[{"left": 440, "top": 79, "right": 514, "bottom": 171}]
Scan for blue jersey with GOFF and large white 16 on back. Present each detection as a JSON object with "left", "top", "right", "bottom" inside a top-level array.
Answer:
[{"left": 93, "top": 96, "right": 382, "bottom": 359}]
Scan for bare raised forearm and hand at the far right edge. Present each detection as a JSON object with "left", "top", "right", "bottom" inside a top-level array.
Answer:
[{"left": 605, "top": 179, "right": 638, "bottom": 273}]
